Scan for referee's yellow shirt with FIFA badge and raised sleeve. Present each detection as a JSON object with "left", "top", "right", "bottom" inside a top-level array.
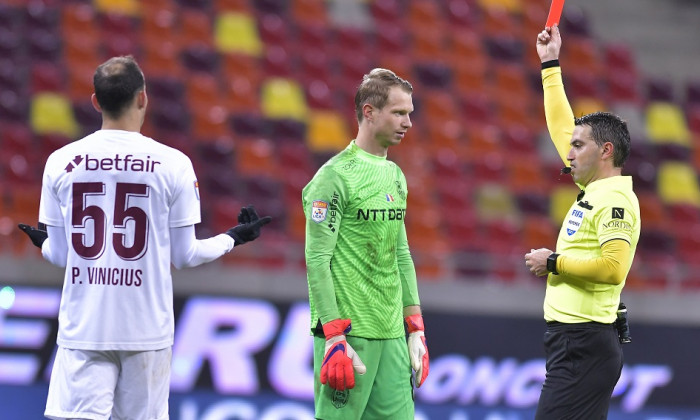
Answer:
[{"left": 542, "top": 67, "right": 641, "bottom": 324}]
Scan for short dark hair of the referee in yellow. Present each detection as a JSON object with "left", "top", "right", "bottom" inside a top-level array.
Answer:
[{"left": 575, "top": 112, "right": 631, "bottom": 168}]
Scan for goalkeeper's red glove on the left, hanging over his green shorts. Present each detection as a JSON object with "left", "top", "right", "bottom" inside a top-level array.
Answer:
[{"left": 321, "top": 319, "right": 367, "bottom": 391}]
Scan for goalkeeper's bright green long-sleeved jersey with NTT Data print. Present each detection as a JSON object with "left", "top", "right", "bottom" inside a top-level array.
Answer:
[{"left": 302, "top": 140, "right": 420, "bottom": 339}]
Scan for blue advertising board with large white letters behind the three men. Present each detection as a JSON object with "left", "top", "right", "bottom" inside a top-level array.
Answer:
[{"left": 0, "top": 288, "right": 700, "bottom": 420}]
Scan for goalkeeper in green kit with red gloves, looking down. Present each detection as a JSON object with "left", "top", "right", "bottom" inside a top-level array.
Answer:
[{"left": 302, "top": 69, "right": 428, "bottom": 420}]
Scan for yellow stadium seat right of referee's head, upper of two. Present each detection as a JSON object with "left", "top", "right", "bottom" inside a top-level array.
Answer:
[{"left": 646, "top": 102, "right": 691, "bottom": 147}]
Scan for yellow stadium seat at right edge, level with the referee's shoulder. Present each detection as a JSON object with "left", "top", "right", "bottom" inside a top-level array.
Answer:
[{"left": 657, "top": 161, "right": 700, "bottom": 207}]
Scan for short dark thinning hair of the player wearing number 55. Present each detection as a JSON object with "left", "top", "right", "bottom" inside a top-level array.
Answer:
[{"left": 92, "top": 55, "right": 146, "bottom": 119}]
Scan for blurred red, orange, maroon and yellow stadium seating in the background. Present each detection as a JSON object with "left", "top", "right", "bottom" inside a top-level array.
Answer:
[{"left": 0, "top": 0, "right": 700, "bottom": 288}]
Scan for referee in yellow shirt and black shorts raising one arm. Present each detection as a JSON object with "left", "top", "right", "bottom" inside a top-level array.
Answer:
[{"left": 525, "top": 25, "right": 641, "bottom": 420}]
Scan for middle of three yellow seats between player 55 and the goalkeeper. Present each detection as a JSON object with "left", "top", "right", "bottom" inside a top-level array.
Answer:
[{"left": 261, "top": 77, "right": 309, "bottom": 122}]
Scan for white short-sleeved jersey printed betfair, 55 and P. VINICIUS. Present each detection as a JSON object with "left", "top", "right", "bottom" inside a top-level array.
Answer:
[{"left": 39, "top": 130, "right": 201, "bottom": 350}]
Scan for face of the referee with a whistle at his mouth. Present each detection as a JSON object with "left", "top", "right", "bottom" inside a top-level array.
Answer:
[{"left": 566, "top": 125, "right": 602, "bottom": 186}]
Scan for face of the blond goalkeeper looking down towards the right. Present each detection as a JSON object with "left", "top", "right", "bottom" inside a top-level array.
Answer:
[{"left": 372, "top": 86, "right": 413, "bottom": 147}]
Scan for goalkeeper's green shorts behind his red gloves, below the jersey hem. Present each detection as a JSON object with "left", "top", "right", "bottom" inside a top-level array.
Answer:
[{"left": 314, "top": 336, "right": 414, "bottom": 420}]
